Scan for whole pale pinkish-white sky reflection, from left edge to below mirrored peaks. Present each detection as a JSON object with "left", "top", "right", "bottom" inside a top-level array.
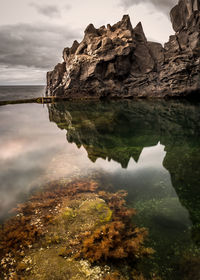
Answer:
[{"left": 0, "top": 104, "right": 191, "bottom": 228}]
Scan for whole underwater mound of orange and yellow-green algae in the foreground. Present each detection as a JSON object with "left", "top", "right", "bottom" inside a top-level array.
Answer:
[{"left": 0, "top": 179, "right": 154, "bottom": 280}]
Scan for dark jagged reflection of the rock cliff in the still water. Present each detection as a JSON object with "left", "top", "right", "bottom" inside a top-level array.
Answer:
[{"left": 49, "top": 101, "right": 200, "bottom": 240}]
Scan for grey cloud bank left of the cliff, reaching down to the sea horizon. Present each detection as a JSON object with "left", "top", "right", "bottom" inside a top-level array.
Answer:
[{"left": 0, "top": 24, "right": 81, "bottom": 85}]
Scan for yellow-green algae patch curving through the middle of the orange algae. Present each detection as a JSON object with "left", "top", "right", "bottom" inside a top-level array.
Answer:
[{"left": 17, "top": 194, "right": 112, "bottom": 280}]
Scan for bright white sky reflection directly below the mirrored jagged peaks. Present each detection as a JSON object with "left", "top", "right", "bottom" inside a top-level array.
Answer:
[{"left": 93, "top": 143, "right": 177, "bottom": 199}]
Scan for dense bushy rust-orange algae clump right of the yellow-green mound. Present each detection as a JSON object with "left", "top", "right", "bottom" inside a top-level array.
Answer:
[{"left": 79, "top": 221, "right": 153, "bottom": 262}]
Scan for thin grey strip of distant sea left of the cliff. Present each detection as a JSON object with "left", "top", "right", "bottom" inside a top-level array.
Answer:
[{"left": 0, "top": 86, "right": 45, "bottom": 101}]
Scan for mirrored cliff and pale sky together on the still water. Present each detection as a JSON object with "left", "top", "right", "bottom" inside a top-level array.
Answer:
[{"left": 0, "top": 101, "right": 200, "bottom": 231}]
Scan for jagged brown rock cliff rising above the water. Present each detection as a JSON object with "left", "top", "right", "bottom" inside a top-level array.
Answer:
[{"left": 47, "top": 0, "right": 200, "bottom": 98}]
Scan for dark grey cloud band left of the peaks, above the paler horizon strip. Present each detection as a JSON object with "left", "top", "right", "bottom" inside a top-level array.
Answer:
[{"left": 0, "top": 24, "right": 80, "bottom": 69}]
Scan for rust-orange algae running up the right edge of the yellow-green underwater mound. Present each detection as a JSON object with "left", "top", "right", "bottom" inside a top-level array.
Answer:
[{"left": 72, "top": 191, "right": 154, "bottom": 263}]
